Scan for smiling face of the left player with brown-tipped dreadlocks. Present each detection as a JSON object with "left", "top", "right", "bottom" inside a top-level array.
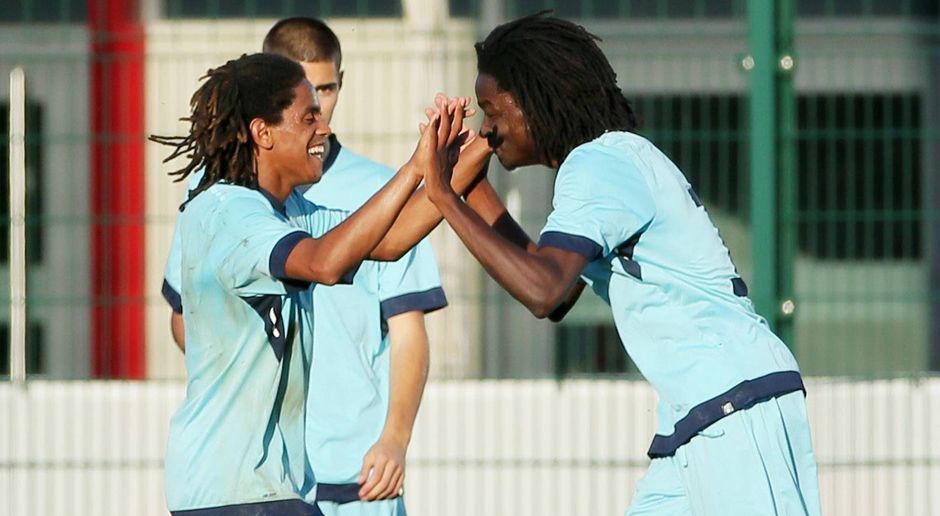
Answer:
[{"left": 271, "top": 79, "right": 330, "bottom": 186}]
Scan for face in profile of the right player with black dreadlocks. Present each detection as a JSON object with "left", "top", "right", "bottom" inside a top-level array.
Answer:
[{"left": 476, "top": 73, "right": 540, "bottom": 170}]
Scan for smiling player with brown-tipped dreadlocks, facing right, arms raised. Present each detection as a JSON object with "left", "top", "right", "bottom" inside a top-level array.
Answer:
[{"left": 151, "top": 54, "right": 467, "bottom": 516}]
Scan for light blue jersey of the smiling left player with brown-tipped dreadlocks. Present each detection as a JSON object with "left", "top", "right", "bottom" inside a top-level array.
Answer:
[{"left": 166, "top": 184, "right": 328, "bottom": 511}]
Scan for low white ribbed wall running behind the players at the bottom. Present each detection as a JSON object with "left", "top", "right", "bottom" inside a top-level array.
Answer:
[{"left": 0, "top": 378, "right": 940, "bottom": 516}]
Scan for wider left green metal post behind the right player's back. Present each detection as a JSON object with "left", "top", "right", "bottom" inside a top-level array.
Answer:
[{"left": 743, "top": 0, "right": 778, "bottom": 326}]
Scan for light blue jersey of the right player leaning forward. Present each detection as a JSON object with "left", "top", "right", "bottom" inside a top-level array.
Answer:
[{"left": 540, "top": 132, "right": 798, "bottom": 444}]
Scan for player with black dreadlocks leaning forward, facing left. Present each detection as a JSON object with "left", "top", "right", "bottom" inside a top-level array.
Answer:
[{"left": 425, "top": 14, "right": 820, "bottom": 516}]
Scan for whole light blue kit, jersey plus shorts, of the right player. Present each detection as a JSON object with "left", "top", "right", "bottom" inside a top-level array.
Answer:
[{"left": 539, "top": 132, "right": 819, "bottom": 516}]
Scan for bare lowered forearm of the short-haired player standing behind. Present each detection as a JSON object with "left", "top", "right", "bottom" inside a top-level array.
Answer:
[{"left": 382, "top": 312, "right": 430, "bottom": 448}]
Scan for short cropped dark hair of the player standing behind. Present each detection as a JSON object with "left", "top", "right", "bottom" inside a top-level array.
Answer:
[{"left": 261, "top": 17, "right": 343, "bottom": 69}]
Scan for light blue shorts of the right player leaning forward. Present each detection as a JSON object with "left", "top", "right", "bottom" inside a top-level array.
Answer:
[{"left": 626, "top": 391, "right": 820, "bottom": 516}]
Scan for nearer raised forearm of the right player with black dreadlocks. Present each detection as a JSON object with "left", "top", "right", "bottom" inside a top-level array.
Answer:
[{"left": 437, "top": 191, "right": 570, "bottom": 317}]
